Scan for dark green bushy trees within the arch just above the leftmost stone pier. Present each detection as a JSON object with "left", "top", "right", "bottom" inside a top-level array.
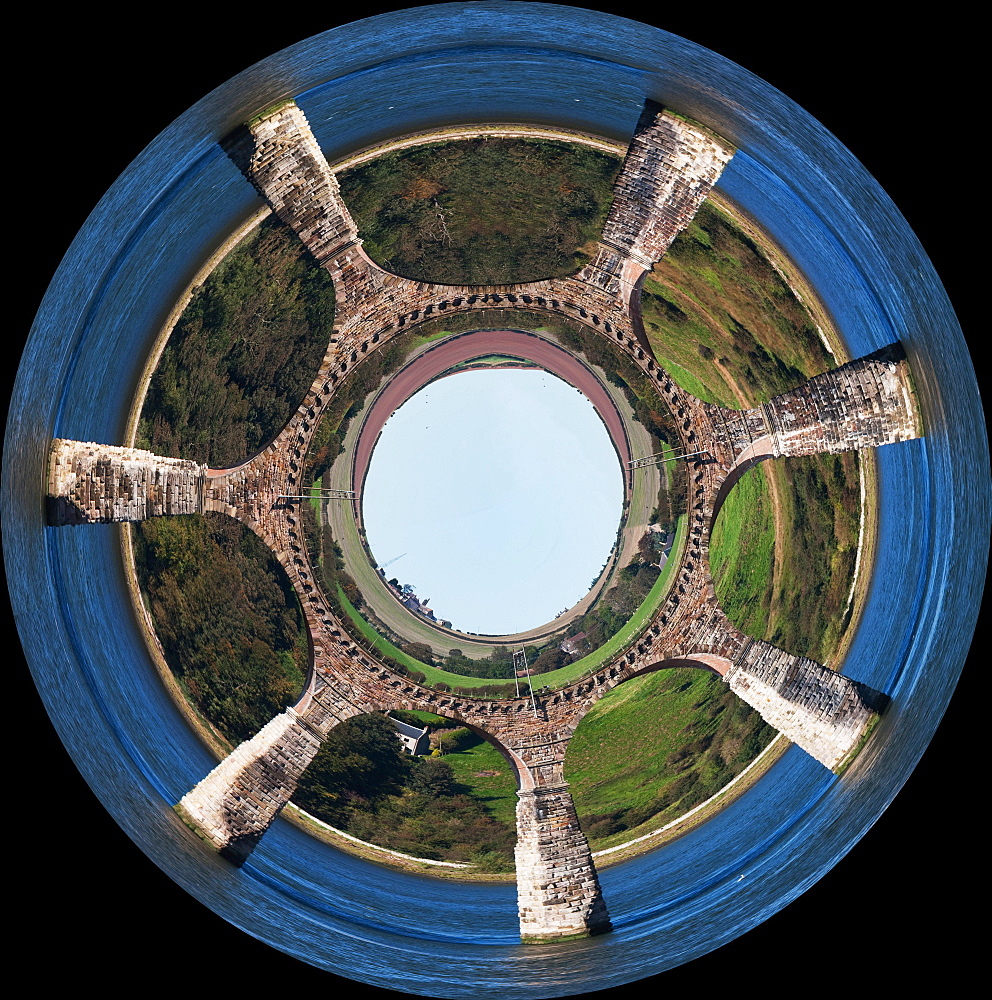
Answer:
[{"left": 137, "top": 218, "right": 334, "bottom": 469}]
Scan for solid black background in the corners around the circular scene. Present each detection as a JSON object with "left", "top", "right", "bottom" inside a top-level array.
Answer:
[{"left": 6, "top": 4, "right": 988, "bottom": 997}]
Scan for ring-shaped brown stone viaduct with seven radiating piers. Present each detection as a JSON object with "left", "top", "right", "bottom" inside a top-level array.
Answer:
[{"left": 48, "top": 103, "right": 919, "bottom": 942}]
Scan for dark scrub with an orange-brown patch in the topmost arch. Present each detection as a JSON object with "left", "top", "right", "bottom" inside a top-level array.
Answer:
[{"left": 338, "top": 137, "right": 620, "bottom": 285}]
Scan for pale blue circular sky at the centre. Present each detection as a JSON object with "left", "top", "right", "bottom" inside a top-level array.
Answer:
[{"left": 363, "top": 369, "right": 623, "bottom": 635}]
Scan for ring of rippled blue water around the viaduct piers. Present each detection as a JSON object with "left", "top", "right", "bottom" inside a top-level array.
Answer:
[{"left": 2, "top": 3, "right": 990, "bottom": 1000}]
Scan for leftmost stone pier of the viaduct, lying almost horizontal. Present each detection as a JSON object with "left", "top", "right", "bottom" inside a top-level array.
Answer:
[{"left": 48, "top": 438, "right": 206, "bottom": 524}]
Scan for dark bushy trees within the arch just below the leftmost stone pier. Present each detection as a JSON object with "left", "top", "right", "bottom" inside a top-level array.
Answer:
[{"left": 133, "top": 514, "right": 309, "bottom": 744}]
